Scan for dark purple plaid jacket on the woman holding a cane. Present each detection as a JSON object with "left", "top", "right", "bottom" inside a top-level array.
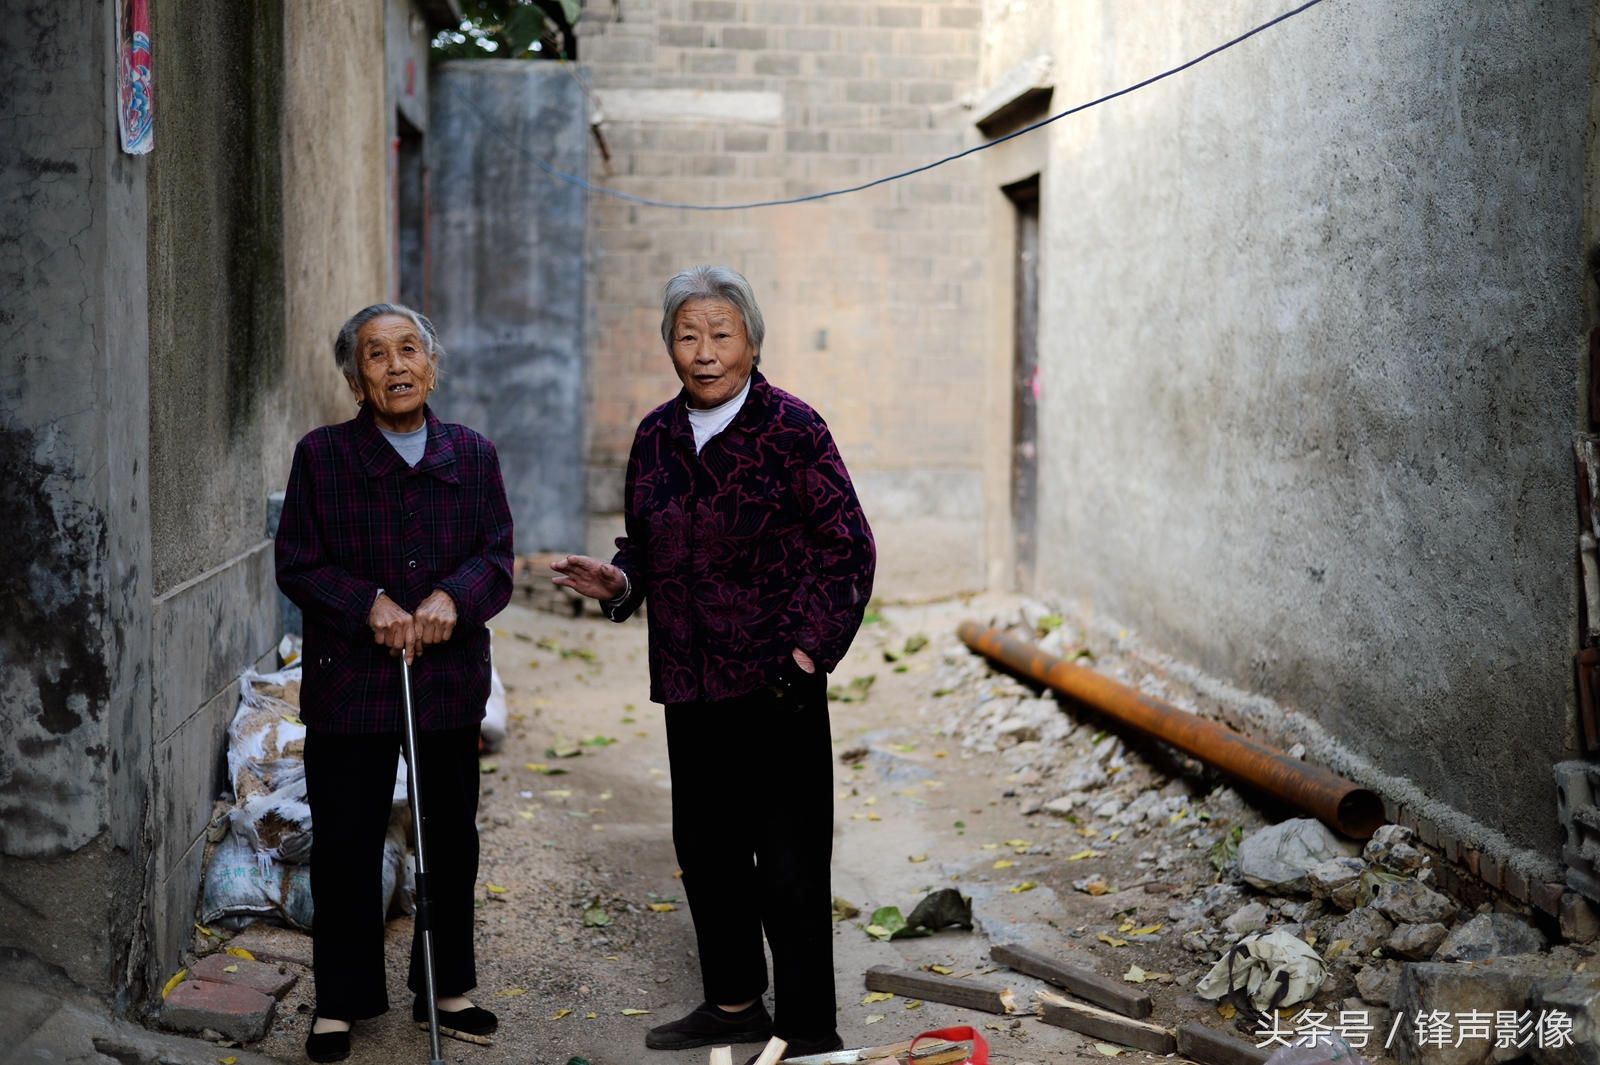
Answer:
[{"left": 277, "top": 404, "right": 512, "bottom": 732}]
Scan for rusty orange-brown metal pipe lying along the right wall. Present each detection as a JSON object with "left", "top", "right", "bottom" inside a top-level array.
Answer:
[{"left": 958, "top": 620, "right": 1384, "bottom": 840}]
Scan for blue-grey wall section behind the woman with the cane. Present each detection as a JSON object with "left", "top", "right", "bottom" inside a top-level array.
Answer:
[{"left": 427, "top": 59, "right": 589, "bottom": 552}]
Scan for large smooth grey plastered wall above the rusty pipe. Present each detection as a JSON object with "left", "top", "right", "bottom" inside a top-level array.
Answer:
[{"left": 1011, "top": 0, "right": 1592, "bottom": 857}]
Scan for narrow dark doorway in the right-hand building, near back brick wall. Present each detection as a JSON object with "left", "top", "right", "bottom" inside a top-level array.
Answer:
[{"left": 1005, "top": 174, "right": 1038, "bottom": 592}]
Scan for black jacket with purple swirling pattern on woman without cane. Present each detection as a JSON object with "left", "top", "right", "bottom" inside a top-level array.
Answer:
[{"left": 608, "top": 373, "right": 877, "bottom": 704}]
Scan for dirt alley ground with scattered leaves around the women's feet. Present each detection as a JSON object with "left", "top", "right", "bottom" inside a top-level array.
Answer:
[{"left": 254, "top": 596, "right": 1384, "bottom": 1065}]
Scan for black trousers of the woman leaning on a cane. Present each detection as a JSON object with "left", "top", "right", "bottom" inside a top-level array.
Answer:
[{"left": 306, "top": 724, "right": 478, "bottom": 1020}]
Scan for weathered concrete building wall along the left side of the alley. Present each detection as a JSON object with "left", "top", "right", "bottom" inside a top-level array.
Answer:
[{"left": 0, "top": 0, "right": 386, "bottom": 1006}]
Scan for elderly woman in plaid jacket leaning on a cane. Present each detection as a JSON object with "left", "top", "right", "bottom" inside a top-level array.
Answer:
[{"left": 277, "top": 304, "right": 512, "bottom": 1062}]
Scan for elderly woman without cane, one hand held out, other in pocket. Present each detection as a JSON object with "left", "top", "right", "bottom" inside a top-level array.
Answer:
[{"left": 555, "top": 267, "right": 875, "bottom": 1060}]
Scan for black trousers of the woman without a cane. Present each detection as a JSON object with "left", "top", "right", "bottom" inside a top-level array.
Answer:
[{"left": 667, "top": 673, "right": 837, "bottom": 1039}]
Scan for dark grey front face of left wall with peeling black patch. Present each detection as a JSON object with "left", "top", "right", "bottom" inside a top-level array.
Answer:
[{"left": 0, "top": 0, "right": 152, "bottom": 998}]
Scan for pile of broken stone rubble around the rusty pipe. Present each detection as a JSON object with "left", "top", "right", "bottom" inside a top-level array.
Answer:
[{"left": 902, "top": 603, "right": 1600, "bottom": 1065}]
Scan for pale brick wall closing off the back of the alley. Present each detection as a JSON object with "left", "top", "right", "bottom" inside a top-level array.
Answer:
[{"left": 581, "top": 0, "right": 1010, "bottom": 596}]
